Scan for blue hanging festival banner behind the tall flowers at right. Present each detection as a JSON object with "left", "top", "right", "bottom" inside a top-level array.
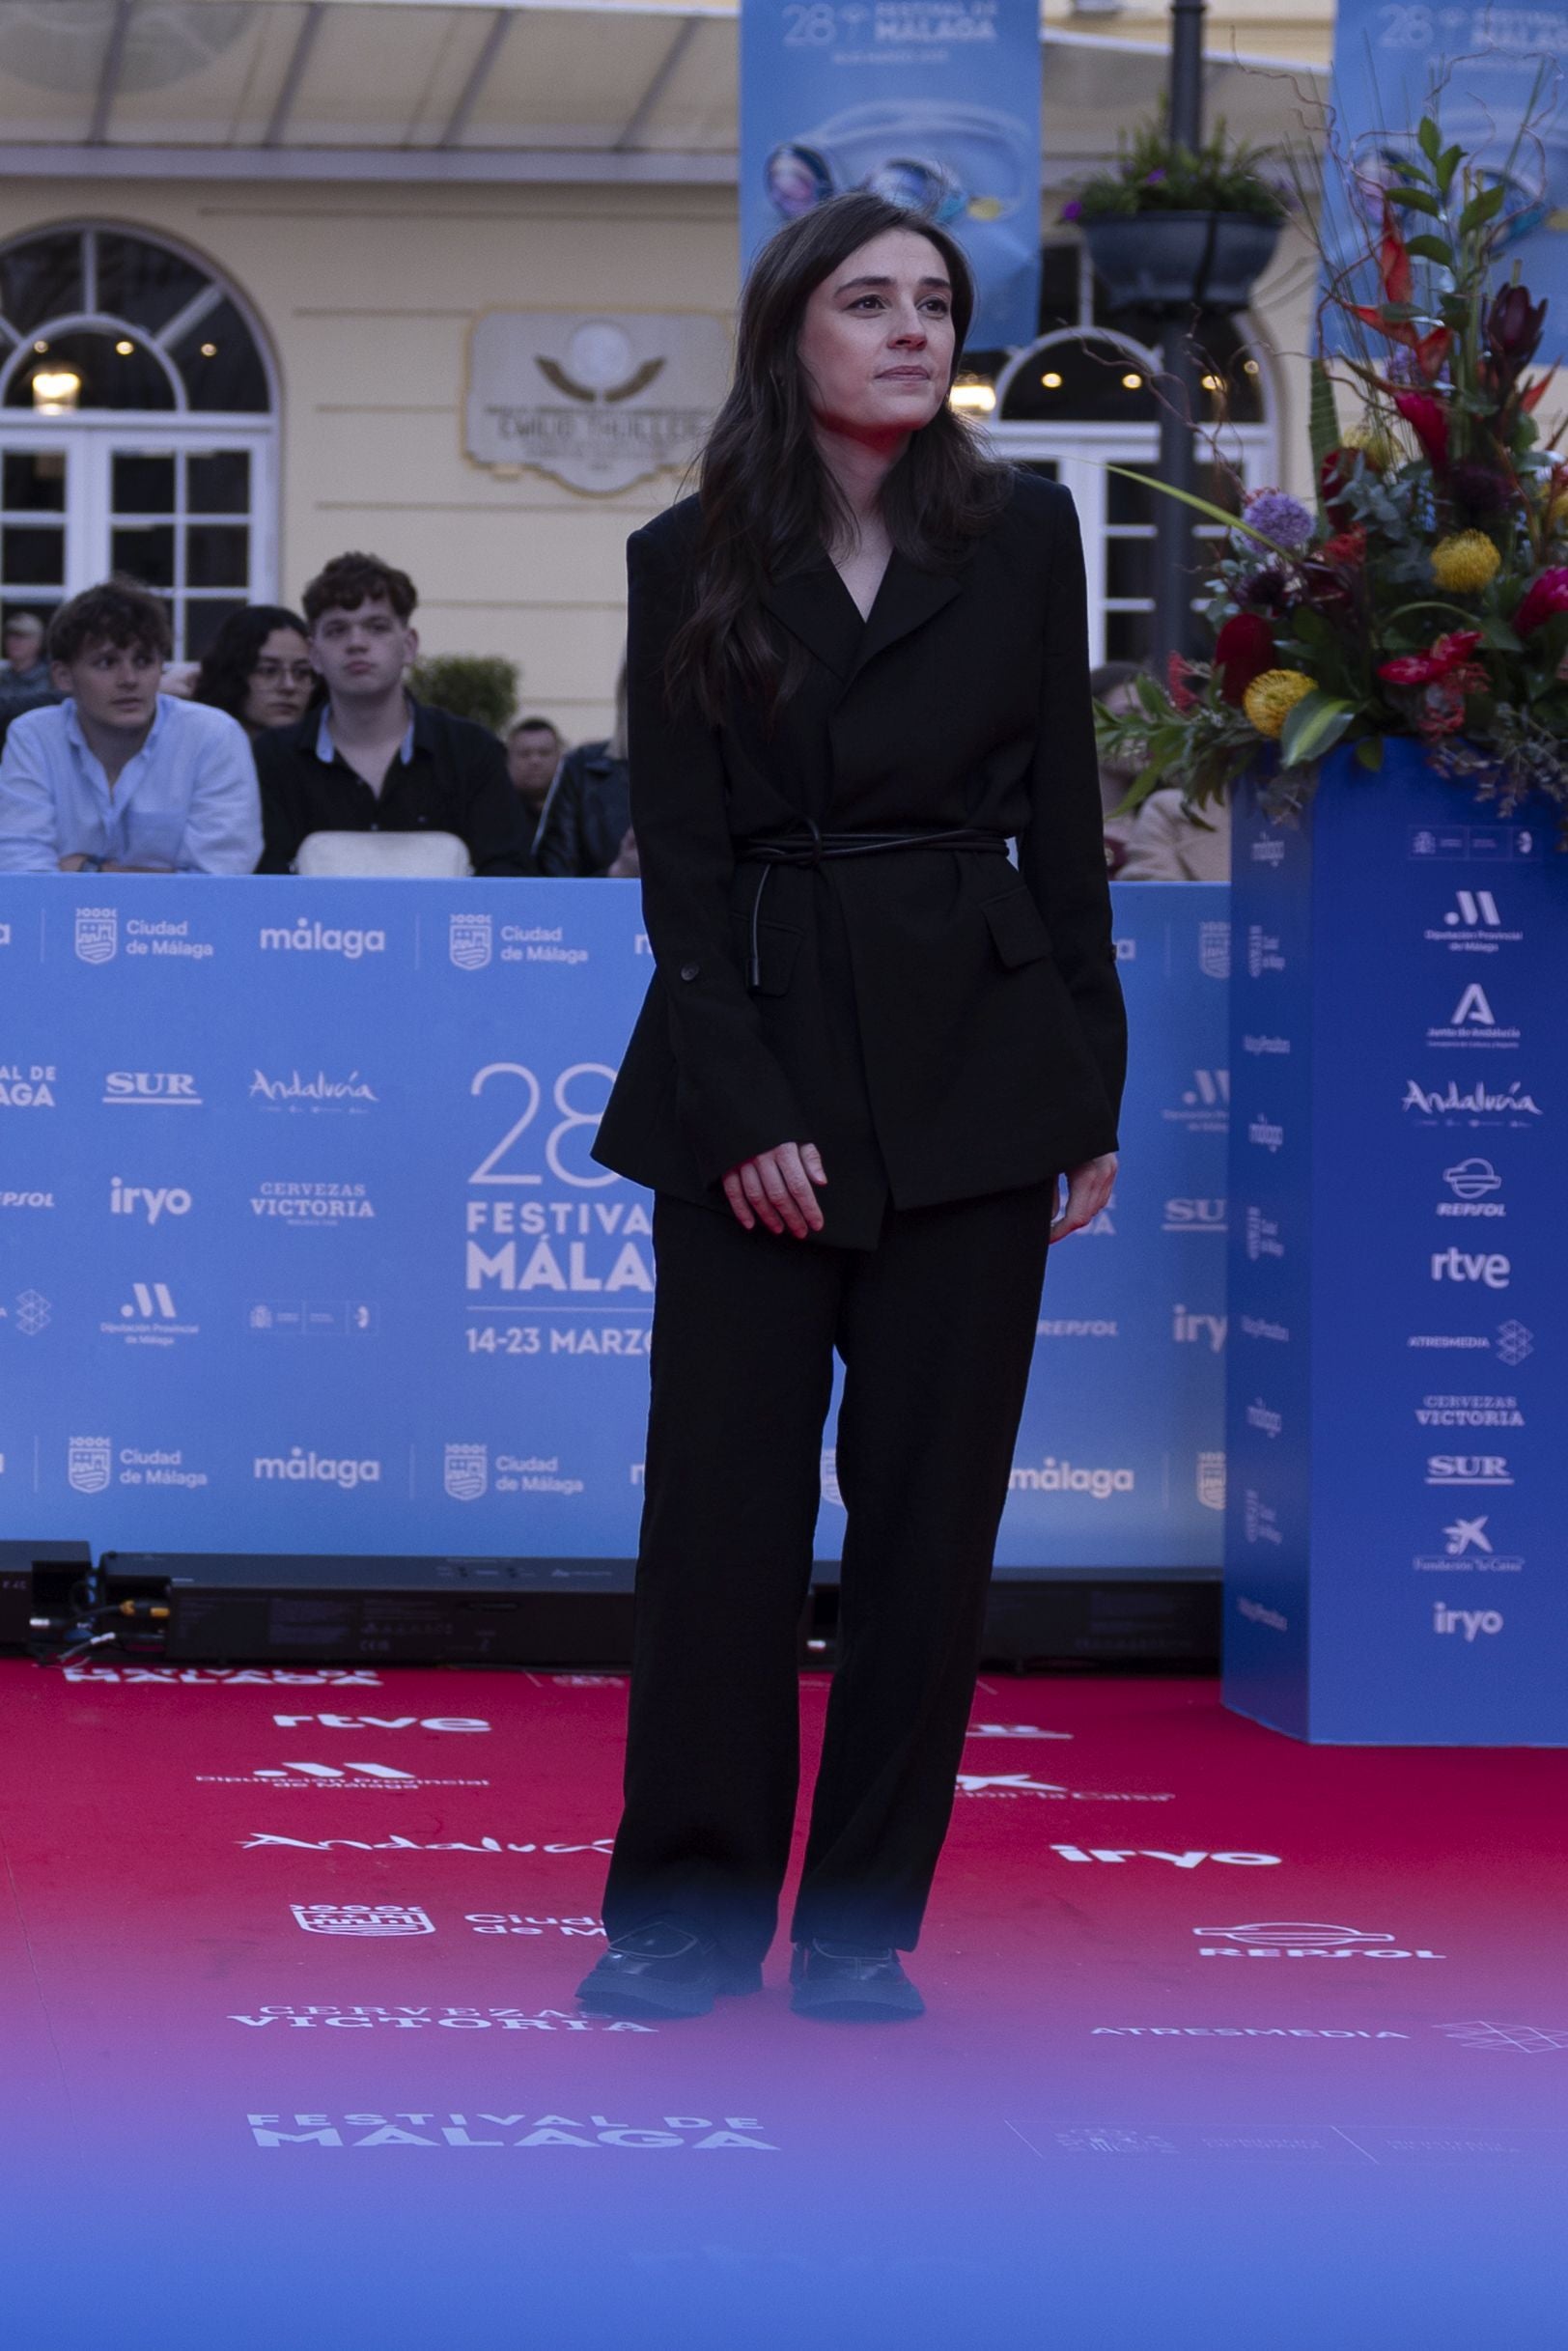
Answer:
[{"left": 1329, "top": 0, "right": 1568, "bottom": 318}]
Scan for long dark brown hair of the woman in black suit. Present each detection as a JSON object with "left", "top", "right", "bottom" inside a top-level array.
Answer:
[{"left": 665, "top": 190, "right": 1006, "bottom": 724}]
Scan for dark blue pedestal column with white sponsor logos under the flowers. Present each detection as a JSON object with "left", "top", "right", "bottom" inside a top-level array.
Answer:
[{"left": 1225, "top": 742, "right": 1568, "bottom": 1747}]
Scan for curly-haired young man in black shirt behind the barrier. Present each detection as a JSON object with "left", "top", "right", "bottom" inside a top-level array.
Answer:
[{"left": 256, "top": 555, "right": 534, "bottom": 875}]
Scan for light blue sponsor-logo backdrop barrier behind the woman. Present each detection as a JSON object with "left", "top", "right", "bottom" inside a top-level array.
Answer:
[{"left": 0, "top": 877, "right": 1229, "bottom": 1568}]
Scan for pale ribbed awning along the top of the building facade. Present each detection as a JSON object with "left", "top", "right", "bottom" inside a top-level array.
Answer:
[{"left": 0, "top": 0, "right": 1321, "bottom": 185}]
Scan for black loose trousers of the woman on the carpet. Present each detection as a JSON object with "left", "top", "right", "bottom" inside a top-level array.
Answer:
[{"left": 604, "top": 1183, "right": 1055, "bottom": 1961}]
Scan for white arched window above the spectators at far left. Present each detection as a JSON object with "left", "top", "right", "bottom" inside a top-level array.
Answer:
[{"left": 0, "top": 223, "right": 275, "bottom": 660}]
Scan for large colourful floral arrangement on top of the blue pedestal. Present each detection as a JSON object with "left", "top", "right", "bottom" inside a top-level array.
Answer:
[{"left": 1098, "top": 113, "right": 1568, "bottom": 847}]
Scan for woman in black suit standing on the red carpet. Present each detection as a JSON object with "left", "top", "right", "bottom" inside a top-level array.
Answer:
[{"left": 578, "top": 195, "right": 1124, "bottom": 2017}]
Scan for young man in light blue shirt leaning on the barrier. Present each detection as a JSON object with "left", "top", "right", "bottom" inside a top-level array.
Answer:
[{"left": 0, "top": 574, "right": 261, "bottom": 875}]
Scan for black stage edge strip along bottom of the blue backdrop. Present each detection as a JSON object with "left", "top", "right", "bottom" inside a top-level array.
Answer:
[{"left": 0, "top": 1542, "right": 1220, "bottom": 1674}]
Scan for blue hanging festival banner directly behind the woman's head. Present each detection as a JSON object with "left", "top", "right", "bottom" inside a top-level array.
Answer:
[{"left": 741, "top": 0, "right": 1039, "bottom": 350}]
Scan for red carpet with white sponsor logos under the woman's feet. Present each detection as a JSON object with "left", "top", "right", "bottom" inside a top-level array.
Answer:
[{"left": 0, "top": 1660, "right": 1568, "bottom": 2351}]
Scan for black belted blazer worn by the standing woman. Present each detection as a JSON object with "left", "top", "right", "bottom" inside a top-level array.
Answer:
[{"left": 595, "top": 472, "right": 1126, "bottom": 1248}]
